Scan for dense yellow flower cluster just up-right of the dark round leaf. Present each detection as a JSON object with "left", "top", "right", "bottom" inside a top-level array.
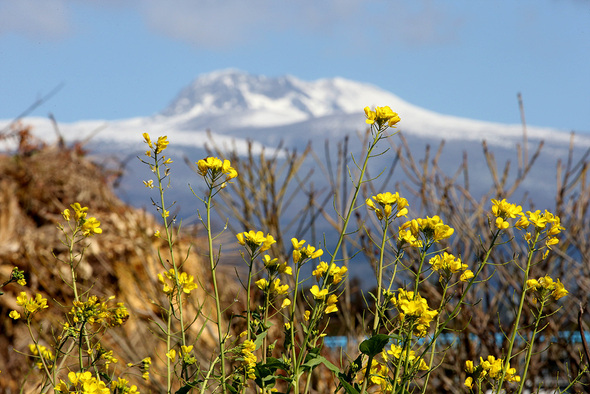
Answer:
[{"left": 392, "top": 289, "right": 438, "bottom": 337}]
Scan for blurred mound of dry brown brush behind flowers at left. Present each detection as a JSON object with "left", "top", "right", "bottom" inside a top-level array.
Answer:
[{"left": 0, "top": 129, "right": 233, "bottom": 392}]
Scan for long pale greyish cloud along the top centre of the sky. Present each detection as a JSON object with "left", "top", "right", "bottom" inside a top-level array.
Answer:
[{"left": 136, "top": 0, "right": 462, "bottom": 49}]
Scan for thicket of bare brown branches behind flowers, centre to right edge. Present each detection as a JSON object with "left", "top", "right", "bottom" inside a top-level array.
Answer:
[{"left": 209, "top": 131, "right": 590, "bottom": 393}]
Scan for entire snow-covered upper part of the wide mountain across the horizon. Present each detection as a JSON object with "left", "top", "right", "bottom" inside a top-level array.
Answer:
[{"left": 0, "top": 69, "right": 590, "bottom": 215}]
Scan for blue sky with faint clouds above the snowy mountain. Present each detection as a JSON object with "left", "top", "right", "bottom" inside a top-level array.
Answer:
[{"left": 0, "top": 0, "right": 590, "bottom": 132}]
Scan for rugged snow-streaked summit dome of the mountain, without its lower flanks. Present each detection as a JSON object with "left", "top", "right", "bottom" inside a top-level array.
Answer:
[{"left": 157, "top": 69, "right": 416, "bottom": 126}]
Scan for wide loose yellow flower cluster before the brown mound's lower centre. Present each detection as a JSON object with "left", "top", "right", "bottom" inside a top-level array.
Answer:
[{"left": 70, "top": 296, "right": 129, "bottom": 327}]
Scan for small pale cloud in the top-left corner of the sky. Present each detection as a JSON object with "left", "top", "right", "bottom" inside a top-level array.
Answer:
[{"left": 0, "top": 0, "right": 71, "bottom": 40}]
